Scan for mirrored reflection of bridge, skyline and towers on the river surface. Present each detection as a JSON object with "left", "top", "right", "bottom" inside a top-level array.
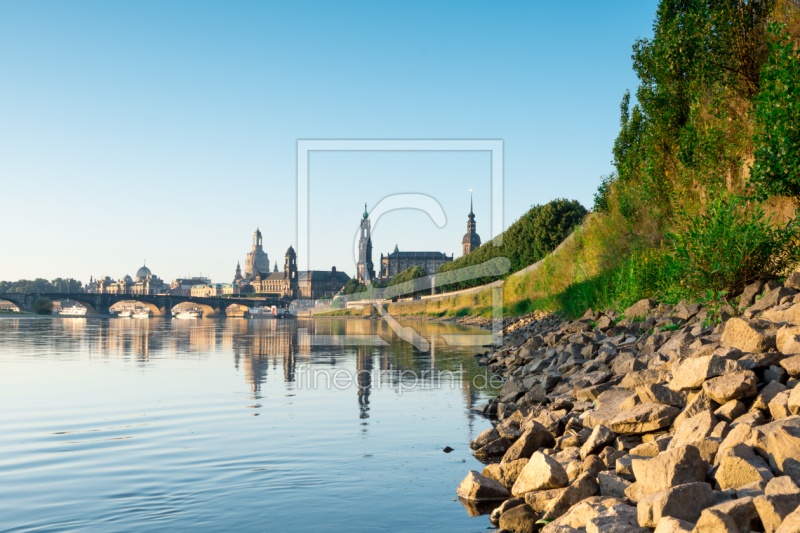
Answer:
[{"left": 0, "top": 317, "right": 491, "bottom": 428}]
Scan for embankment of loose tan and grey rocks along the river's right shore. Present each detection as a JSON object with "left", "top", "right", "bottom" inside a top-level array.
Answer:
[{"left": 458, "top": 273, "right": 800, "bottom": 533}]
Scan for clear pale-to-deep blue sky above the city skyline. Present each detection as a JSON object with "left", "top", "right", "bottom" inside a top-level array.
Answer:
[{"left": 0, "top": 0, "right": 656, "bottom": 282}]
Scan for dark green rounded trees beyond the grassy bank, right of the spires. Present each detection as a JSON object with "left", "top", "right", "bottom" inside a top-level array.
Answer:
[{"left": 436, "top": 199, "right": 587, "bottom": 291}]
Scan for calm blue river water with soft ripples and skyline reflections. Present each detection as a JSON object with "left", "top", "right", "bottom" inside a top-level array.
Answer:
[{"left": 0, "top": 317, "right": 500, "bottom": 532}]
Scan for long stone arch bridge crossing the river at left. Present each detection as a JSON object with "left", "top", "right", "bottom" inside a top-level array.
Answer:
[{"left": 0, "top": 292, "right": 290, "bottom": 317}]
